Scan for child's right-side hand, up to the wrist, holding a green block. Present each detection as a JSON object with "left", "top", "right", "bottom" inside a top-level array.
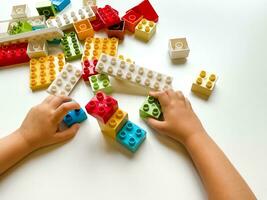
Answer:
[{"left": 147, "top": 90, "right": 205, "bottom": 144}]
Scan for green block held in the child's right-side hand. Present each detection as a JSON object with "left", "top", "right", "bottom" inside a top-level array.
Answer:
[{"left": 139, "top": 96, "right": 162, "bottom": 119}]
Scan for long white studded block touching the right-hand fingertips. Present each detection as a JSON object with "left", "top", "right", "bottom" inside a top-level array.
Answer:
[{"left": 96, "top": 53, "right": 172, "bottom": 91}]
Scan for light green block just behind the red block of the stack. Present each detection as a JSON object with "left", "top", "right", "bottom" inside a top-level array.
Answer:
[{"left": 89, "top": 74, "right": 112, "bottom": 94}]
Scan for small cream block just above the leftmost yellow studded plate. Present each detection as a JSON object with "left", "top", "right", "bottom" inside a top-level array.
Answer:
[{"left": 27, "top": 41, "right": 48, "bottom": 58}]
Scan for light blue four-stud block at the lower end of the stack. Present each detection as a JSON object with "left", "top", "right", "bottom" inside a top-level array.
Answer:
[{"left": 116, "top": 121, "right": 146, "bottom": 152}]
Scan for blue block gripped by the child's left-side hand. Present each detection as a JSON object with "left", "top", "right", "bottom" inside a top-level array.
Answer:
[{"left": 63, "top": 109, "right": 87, "bottom": 127}]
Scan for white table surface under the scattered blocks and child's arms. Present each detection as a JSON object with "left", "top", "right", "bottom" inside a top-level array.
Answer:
[{"left": 0, "top": 0, "right": 267, "bottom": 200}]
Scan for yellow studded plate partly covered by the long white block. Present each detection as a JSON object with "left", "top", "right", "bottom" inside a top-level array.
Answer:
[{"left": 82, "top": 38, "right": 119, "bottom": 60}]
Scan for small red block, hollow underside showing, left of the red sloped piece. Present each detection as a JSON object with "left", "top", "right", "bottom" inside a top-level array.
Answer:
[{"left": 122, "top": 10, "right": 143, "bottom": 33}]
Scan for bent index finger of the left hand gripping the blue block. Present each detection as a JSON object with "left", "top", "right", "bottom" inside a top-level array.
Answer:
[{"left": 54, "top": 101, "right": 80, "bottom": 122}]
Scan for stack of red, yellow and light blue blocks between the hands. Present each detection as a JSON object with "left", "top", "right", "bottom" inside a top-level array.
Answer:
[{"left": 85, "top": 92, "right": 146, "bottom": 152}]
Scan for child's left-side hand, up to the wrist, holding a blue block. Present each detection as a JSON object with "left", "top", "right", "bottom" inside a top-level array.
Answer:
[{"left": 18, "top": 95, "right": 80, "bottom": 150}]
